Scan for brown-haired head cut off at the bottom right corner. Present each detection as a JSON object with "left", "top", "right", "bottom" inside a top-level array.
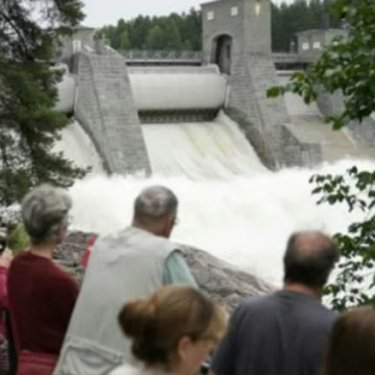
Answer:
[{"left": 324, "top": 306, "right": 375, "bottom": 375}]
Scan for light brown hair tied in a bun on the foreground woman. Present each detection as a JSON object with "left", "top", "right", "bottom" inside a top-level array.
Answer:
[{"left": 119, "top": 285, "right": 227, "bottom": 365}]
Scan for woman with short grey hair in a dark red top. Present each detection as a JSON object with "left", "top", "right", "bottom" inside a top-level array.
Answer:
[{"left": 8, "top": 185, "right": 78, "bottom": 375}]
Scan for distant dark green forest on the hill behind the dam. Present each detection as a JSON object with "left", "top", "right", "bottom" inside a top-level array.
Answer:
[{"left": 99, "top": 0, "right": 340, "bottom": 52}]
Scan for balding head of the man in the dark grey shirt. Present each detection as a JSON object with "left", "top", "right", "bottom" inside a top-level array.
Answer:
[{"left": 284, "top": 232, "right": 339, "bottom": 289}]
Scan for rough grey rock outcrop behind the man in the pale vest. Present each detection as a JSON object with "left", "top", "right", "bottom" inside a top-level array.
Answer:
[{"left": 55, "top": 232, "right": 275, "bottom": 312}]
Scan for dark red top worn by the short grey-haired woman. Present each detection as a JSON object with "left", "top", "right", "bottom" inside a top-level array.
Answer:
[{"left": 8, "top": 251, "right": 78, "bottom": 354}]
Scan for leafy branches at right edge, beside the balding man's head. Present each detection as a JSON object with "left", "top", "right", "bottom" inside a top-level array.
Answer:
[{"left": 311, "top": 167, "right": 375, "bottom": 310}]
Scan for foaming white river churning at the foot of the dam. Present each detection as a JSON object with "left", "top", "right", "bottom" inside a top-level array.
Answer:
[{"left": 71, "top": 160, "right": 375, "bottom": 284}]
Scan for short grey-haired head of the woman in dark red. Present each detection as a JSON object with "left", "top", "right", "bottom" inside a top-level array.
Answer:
[{"left": 21, "top": 184, "right": 72, "bottom": 245}]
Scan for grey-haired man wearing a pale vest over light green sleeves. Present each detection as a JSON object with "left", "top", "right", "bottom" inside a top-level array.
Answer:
[{"left": 54, "top": 186, "right": 196, "bottom": 375}]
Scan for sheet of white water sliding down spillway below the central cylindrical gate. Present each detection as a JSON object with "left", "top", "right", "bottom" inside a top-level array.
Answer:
[{"left": 142, "top": 113, "right": 266, "bottom": 181}]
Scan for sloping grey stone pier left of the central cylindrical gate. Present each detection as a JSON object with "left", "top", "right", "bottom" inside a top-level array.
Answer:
[{"left": 75, "top": 52, "right": 150, "bottom": 174}]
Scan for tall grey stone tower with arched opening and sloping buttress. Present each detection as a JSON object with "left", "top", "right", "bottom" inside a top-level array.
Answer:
[{"left": 202, "top": 0, "right": 316, "bottom": 168}]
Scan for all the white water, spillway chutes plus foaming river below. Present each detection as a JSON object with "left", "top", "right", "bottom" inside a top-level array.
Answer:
[{"left": 58, "top": 120, "right": 375, "bottom": 284}]
